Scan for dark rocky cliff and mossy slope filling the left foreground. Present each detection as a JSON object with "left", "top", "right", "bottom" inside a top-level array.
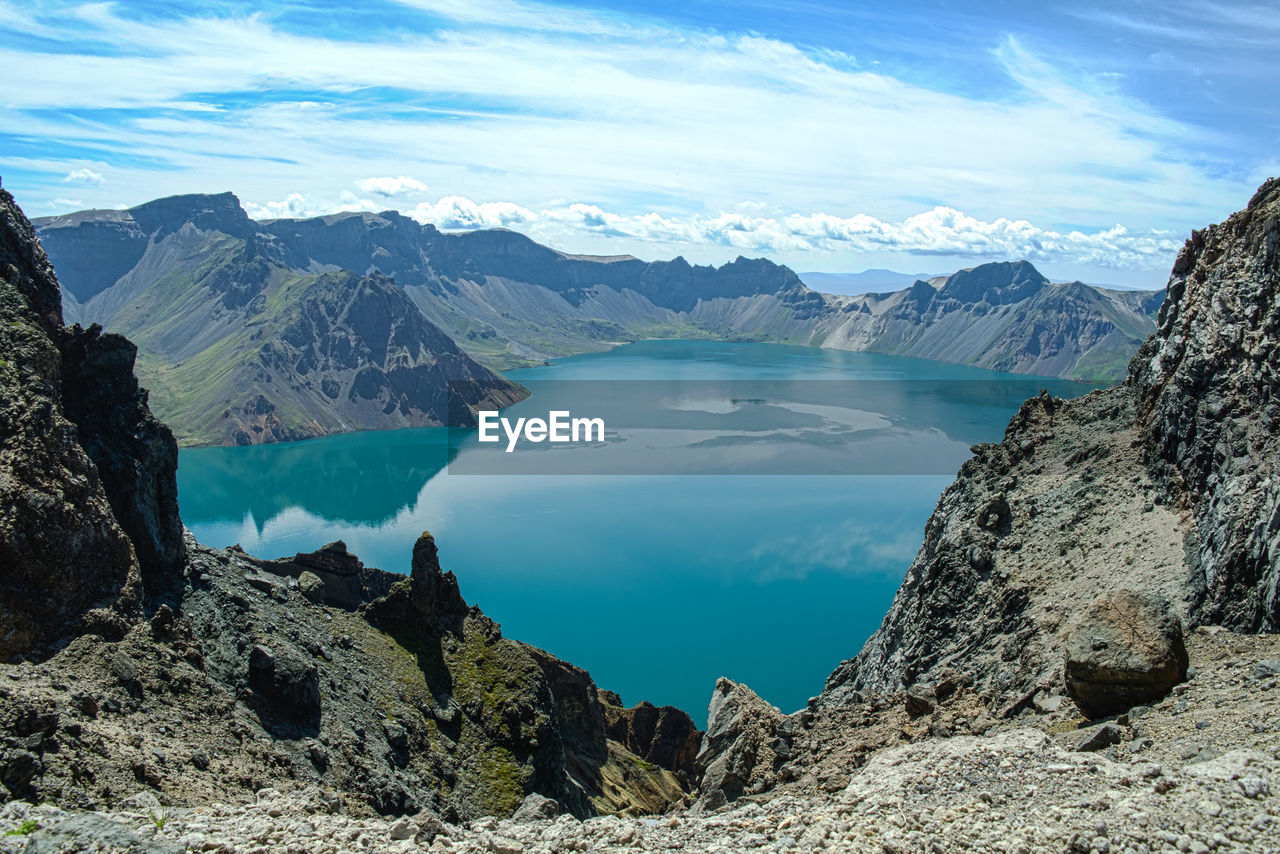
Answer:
[{"left": 0, "top": 193, "right": 698, "bottom": 821}]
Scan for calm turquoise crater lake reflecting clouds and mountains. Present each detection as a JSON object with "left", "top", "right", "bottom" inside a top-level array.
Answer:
[{"left": 178, "top": 341, "right": 1088, "bottom": 725}]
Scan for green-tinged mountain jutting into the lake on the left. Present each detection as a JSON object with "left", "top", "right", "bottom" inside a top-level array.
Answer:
[{"left": 45, "top": 193, "right": 526, "bottom": 444}]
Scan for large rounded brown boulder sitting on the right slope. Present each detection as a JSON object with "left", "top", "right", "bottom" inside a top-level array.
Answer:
[{"left": 1065, "top": 589, "right": 1187, "bottom": 717}]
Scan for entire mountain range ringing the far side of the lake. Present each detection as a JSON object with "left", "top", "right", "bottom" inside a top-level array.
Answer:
[{"left": 35, "top": 193, "right": 1164, "bottom": 444}]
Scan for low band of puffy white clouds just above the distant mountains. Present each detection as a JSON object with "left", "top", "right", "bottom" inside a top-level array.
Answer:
[{"left": 240, "top": 193, "right": 1181, "bottom": 269}]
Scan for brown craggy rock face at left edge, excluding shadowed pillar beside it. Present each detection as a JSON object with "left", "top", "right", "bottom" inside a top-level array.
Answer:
[{"left": 0, "top": 191, "right": 141, "bottom": 661}]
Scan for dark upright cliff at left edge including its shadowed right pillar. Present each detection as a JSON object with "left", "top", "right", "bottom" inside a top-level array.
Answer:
[{"left": 0, "top": 191, "right": 186, "bottom": 657}]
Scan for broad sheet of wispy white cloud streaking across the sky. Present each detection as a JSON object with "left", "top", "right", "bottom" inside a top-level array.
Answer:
[{"left": 0, "top": 0, "right": 1257, "bottom": 280}]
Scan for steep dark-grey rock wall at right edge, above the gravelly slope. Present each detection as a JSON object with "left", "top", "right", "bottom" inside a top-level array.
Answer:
[{"left": 1130, "top": 178, "right": 1280, "bottom": 631}]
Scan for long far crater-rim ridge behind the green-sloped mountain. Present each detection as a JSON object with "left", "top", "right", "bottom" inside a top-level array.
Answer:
[{"left": 37, "top": 193, "right": 1158, "bottom": 404}]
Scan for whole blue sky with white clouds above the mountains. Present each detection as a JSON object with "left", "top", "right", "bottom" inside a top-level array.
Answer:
[{"left": 0, "top": 0, "right": 1280, "bottom": 287}]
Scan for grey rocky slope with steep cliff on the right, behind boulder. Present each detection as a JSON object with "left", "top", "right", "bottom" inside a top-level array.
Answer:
[{"left": 819, "top": 181, "right": 1280, "bottom": 714}]
